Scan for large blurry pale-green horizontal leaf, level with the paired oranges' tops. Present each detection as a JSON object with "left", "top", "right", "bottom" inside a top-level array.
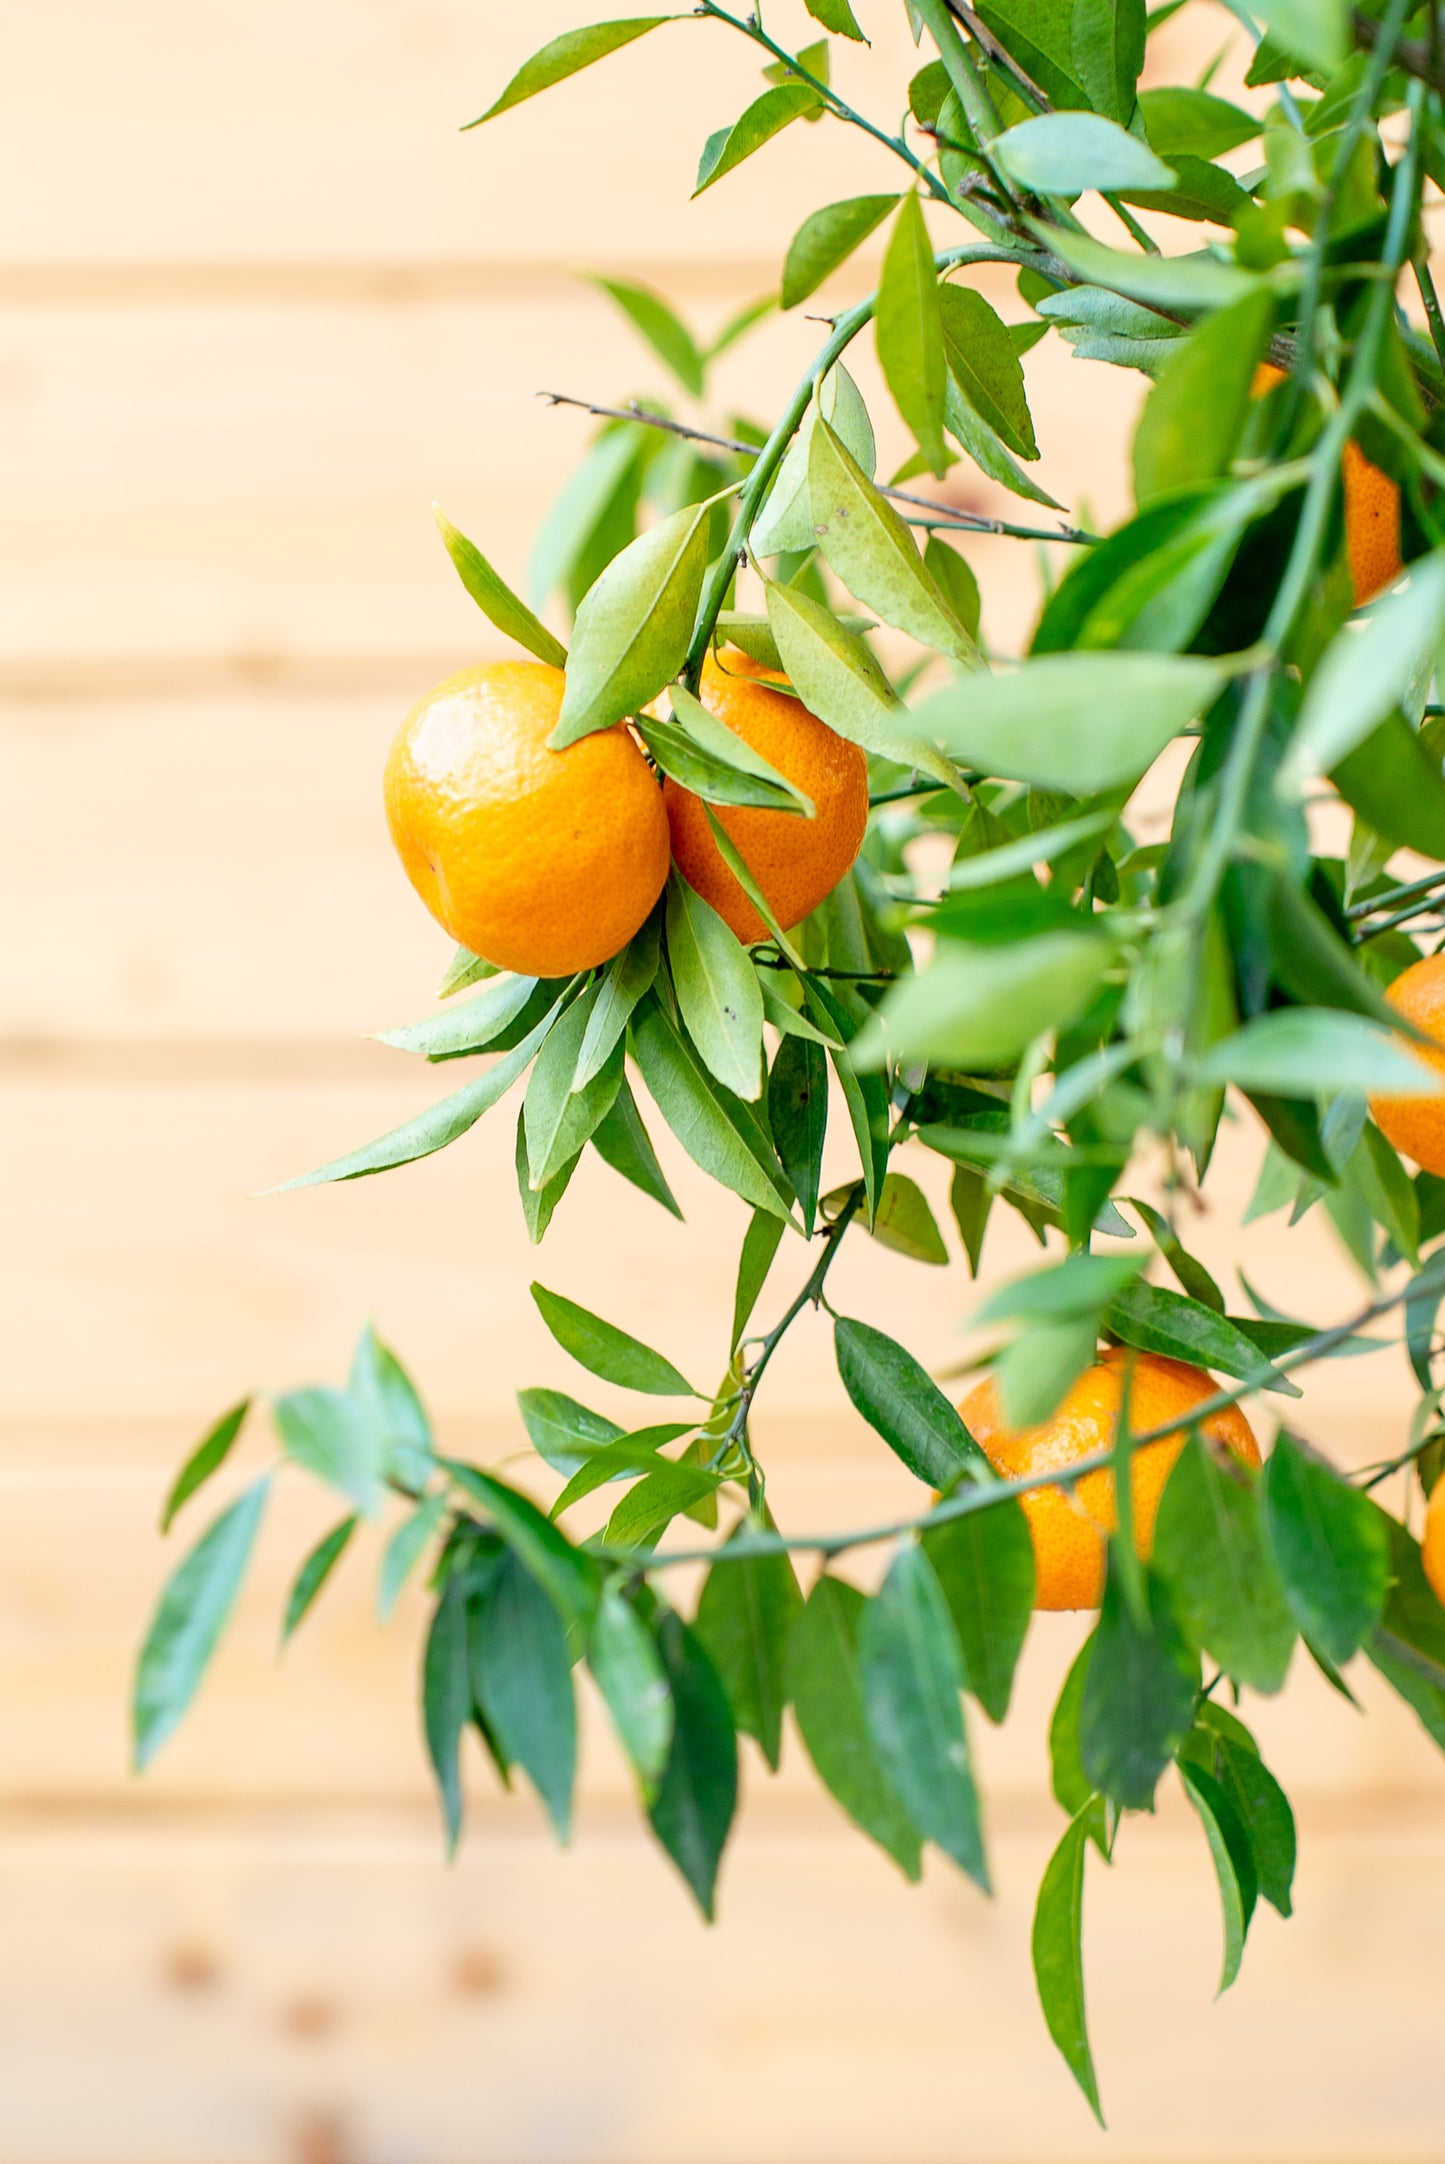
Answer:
[{"left": 913, "top": 654, "right": 1229, "bottom": 796}]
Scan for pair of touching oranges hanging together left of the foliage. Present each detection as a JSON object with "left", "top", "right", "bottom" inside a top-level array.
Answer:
[{"left": 385, "top": 647, "right": 867, "bottom": 976}]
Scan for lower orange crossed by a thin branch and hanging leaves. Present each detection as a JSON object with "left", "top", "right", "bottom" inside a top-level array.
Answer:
[{"left": 958, "top": 1346, "right": 1259, "bottom": 1608}]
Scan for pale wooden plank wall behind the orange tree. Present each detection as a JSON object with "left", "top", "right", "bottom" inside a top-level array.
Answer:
[{"left": 0, "top": 0, "right": 1445, "bottom": 2164}]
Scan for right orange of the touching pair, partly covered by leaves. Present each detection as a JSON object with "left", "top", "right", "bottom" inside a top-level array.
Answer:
[{"left": 662, "top": 647, "right": 867, "bottom": 946}]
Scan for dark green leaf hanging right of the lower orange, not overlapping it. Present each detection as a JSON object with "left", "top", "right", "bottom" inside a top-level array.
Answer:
[{"left": 1263, "top": 1433, "right": 1389, "bottom": 1666}]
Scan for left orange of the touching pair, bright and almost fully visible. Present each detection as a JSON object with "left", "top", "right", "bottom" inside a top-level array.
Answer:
[{"left": 385, "top": 662, "right": 668, "bottom": 976}]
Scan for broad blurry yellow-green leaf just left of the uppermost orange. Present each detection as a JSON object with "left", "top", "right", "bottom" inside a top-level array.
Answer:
[{"left": 1134, "top": 288, "right": 1274, "bottom": 506}]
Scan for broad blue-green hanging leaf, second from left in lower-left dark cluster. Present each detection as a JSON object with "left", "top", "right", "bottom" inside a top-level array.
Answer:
[{"left": 467, "top": 1549, "right": 578, "bottom": 1842}]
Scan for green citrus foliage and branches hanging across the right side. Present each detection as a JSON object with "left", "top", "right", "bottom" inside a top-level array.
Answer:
[{"left": 136, "top": 0, "right": 1445, "bottom": 2110}]
